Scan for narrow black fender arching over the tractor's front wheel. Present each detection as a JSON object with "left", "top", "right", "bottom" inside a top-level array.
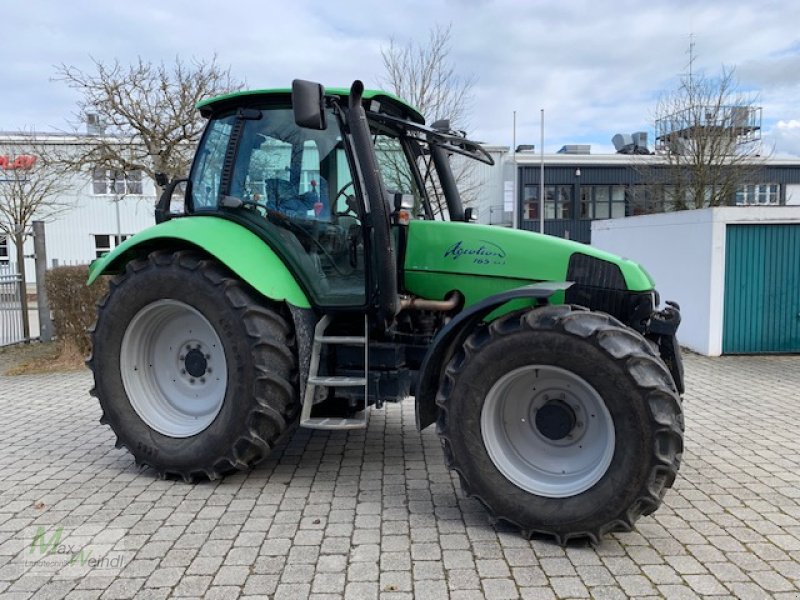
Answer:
[{"left": 414, "top": 281, "right": 572, "bottom": 431}]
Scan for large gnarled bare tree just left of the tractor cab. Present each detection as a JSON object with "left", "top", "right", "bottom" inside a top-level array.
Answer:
[{"left": 55, "top": 57, "right": 242, "bottom": 192}]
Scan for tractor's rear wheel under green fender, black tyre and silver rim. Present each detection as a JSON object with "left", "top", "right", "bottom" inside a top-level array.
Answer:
[{"left": 88, "top": 251, "right": 299, "bottom": 480}]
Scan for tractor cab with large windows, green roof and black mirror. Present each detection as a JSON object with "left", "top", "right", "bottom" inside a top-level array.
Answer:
[{"left": 157, "top": 82, "right": 492, "bottom": 322}]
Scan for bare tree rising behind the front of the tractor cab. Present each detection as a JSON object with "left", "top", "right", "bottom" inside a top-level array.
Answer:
[{"left": 379, "top": 26, "right": 479, "bottom": 213}]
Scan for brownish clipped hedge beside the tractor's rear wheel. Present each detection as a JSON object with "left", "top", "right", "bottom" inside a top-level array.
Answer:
[{"left": 45, "top": 266, "right": 108, "bottom": 356}]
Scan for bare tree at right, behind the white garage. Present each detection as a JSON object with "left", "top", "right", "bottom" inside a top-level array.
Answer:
[{"left": 641, "top": 68, "right": 763, "bottom": 210}]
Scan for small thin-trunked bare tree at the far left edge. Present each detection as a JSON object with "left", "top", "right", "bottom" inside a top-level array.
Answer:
[{"left": 0, "top": 133, "right": 71, "bottom": 339}]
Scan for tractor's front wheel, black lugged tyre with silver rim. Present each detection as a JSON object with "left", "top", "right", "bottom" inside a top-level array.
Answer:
[{"left": 437, "top": 306, "right": 683, "bottom": 544}]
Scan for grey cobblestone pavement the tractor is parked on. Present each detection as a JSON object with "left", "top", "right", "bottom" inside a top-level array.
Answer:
[{"left": 0, "top": 356, "right": 800, "bottom": 600}]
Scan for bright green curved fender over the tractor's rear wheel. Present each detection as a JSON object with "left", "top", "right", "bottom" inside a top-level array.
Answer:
[{"left": 87, "top": 216, "right": 311, "bottom": 308}]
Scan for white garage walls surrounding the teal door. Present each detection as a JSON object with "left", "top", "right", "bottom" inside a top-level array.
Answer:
[{"left": 592, "top": 206, "right": 800, "bottom": 356}]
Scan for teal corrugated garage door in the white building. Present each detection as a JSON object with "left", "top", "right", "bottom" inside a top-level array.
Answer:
[{"left": 722, "top": 223, "right": 800, "bottom": 354}]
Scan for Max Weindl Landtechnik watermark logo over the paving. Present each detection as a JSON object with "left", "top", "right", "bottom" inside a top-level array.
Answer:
[{"left": 25, "top": 525, "right": 125, "bottom": 575}]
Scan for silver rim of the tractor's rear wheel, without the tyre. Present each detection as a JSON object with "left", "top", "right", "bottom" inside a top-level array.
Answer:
[{"left": 120, "top": 300, "right": 228, "bottom": 438}]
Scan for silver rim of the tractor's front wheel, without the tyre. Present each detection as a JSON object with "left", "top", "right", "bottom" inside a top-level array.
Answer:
[{"left": 481, "top": 365, "right": 615, "bottom": 498}]
